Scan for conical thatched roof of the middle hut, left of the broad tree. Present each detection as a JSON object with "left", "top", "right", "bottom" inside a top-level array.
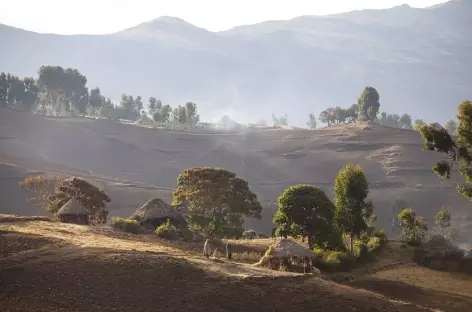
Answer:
[{"left": 130, "top": 198, "right": 186, "bottom": 223}]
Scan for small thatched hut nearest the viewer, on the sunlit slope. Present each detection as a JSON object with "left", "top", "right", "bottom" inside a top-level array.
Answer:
[{"left": 255, "top": 238, "right": 319, "bottom": 273}]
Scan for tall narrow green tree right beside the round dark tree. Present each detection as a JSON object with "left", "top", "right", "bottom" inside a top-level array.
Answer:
[{"left": 334, "top": 163, "right": 375, "bottom": 252}]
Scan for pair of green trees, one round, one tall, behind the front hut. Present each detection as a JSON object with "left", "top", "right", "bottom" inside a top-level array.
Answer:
[{"left": 273, "top": 164, "right": 375, "bottom": 252}]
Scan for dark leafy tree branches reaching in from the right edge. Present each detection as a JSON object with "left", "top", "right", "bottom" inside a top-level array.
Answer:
[{"left": 420, "top": 101, "right": 472, "bottom": 199}]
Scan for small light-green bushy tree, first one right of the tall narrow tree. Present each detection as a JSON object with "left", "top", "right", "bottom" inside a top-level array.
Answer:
[{"left": 398, "top": 208, "right": 428, "bottom": 246}]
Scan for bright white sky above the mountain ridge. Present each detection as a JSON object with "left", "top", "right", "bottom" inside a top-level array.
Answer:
[{"left": 0, "top": 0, "right": 446, "bottom": 34}]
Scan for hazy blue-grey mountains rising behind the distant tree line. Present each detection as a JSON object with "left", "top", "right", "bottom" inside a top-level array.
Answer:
[{"left": 0, "top": 0, "right": 472, "bottom": 125}]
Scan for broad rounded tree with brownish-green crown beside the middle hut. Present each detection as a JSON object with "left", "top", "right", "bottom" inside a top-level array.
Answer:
[{"left": 172, "top": 167, "right": 262, "bottom": 238}]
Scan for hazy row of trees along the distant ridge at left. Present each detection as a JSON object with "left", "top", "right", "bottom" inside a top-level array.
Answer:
[{"left": 0, "top": 66, "right": 200, "bottom": 125}]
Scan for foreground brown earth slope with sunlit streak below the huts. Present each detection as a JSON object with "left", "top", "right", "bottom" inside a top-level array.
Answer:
[{"left": 0, "top": 216, "right": 472, "bottom": 312}]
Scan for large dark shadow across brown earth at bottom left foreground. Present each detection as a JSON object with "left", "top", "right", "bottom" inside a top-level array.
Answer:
[{"left": 0, "top": 254, "right": 432, "bottom": 312}]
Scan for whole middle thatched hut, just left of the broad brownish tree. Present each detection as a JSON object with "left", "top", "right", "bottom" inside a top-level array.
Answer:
[{"left": 129, "top": 198, "right": 192, "bottom": 239}]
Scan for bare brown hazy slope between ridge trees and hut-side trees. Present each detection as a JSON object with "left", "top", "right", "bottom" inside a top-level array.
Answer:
[{"left": 0, "top": 110, "right": 470, "bottom": 232}]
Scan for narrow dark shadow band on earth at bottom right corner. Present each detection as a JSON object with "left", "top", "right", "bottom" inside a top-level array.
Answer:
[{"left": 348, "top": 278, "right": 472, "bottom": 312}]
